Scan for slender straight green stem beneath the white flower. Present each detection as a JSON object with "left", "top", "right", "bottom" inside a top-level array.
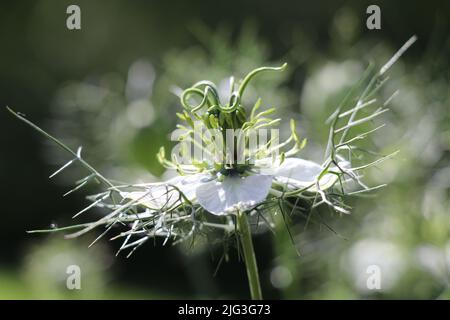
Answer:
[{"left": 237, "top": 212, "right": 262, "bottom": 300}]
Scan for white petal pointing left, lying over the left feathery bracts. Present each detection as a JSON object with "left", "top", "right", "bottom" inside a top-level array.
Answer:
[{"left": 121, "top": 174, "right": 211, "bottom": 210}]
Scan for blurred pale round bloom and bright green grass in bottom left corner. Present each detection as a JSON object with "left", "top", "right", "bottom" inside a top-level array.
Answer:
[{"left": 0, "top": 237, "right": 175, "bottom": 300}]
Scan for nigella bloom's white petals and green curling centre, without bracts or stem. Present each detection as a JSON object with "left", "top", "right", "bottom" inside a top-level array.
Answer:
[{"left": 121, "top": 65, "right": 356, "bottom": 216}]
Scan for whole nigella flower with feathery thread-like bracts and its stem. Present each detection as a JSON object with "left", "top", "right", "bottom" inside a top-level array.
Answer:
[{"left": 8, "top": 37, "right": 416, "bottom": 299}]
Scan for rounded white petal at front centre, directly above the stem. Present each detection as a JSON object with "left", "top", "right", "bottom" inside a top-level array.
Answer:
[{"left": 196, "top": 175, "right": 272, "bottom": 215}]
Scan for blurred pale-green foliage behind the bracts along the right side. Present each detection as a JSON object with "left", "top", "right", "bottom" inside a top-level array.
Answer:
[{"left": 272, "top": 16, "right": 450, "bottom": 299}]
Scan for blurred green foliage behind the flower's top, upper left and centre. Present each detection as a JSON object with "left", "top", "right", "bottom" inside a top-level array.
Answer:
[{"left": 47, "top": 22, "right": 294, "bottom": 182}]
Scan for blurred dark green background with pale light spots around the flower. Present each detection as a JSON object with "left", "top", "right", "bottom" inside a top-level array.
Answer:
[{"left": 0, "top": 0, "right": 450, "bottom": 299}]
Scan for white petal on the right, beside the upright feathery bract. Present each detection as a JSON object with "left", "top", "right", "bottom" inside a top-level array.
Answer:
[{"left": 275, "top": 158, "right": 337, "bottom": 192}]
